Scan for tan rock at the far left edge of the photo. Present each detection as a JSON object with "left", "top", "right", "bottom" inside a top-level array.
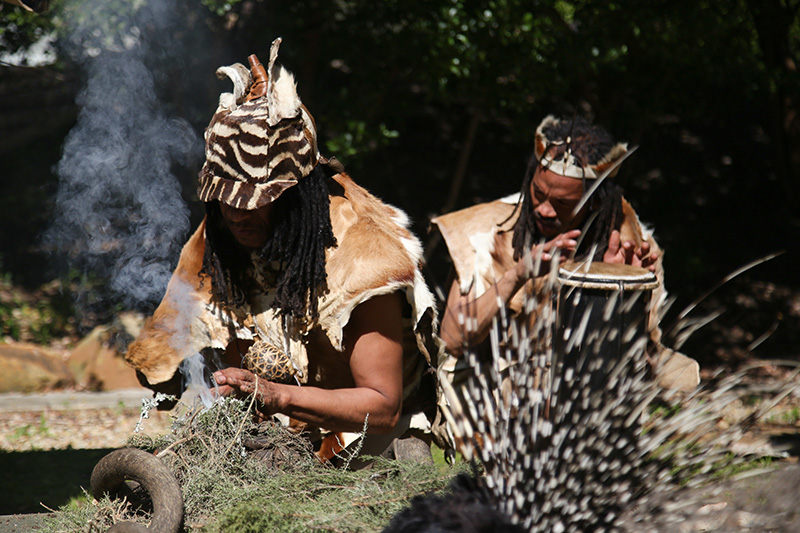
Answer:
[{"left": 0, "top": 343, "right": 75, "bottom": 392}]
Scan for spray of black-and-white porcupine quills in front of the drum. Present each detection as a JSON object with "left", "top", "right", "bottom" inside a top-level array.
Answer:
[{"left": 396, "top": 258, "right": 790, "bottom": 532}]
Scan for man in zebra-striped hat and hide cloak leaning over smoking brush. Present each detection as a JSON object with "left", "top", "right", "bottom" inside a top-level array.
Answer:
[{"left": 127, "top": 39, "right": 442, "bottom": 462}]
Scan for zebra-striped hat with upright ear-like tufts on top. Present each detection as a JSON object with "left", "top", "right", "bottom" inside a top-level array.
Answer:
[{"left": 197, "top": 38, "right": 320, "bottom": 210}]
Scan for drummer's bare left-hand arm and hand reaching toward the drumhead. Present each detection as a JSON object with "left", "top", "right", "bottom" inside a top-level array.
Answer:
[{"left": 439, "top": 230, "right": 580, "bottom": 357}]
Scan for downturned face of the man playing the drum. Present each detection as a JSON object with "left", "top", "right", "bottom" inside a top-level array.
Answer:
[{"left": 530, "top": 167, "right": 587, "bottom": 239}]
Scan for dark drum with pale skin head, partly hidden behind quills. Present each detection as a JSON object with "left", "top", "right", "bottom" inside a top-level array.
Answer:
[{"left": 552, "top": 262, "right": 659, "bottom": 386}]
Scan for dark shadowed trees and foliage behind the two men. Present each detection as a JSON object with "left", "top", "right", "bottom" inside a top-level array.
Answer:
[{"left": 0, "top": 0, "right": 800, "bottom": 364}]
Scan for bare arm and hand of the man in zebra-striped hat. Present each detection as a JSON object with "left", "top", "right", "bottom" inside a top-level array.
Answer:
[{"left": 214, "top": 294, "right": 403, "bottom": 433}]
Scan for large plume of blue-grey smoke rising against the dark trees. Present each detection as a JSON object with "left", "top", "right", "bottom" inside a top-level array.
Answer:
[{"left": 45, "top": 0, "right": 202, "bottom": 306}]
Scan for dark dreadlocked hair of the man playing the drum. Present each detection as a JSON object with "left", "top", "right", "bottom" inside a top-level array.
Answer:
[{"left": 509, "top": 117, "right": 622, "bottom": 260}]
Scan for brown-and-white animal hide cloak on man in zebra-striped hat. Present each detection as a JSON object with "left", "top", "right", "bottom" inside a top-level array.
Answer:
[{"left": 125, "top": 173, "right": 443, "bottom": 422}]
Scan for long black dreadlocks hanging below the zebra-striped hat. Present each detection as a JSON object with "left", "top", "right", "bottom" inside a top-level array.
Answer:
[{"left": 201, "top": 165, "right": 336, "bottom": 320}]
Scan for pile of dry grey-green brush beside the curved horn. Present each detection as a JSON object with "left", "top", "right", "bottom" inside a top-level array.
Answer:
[{"left": 36, "top": 398, "right": 467, "bottom": 533}]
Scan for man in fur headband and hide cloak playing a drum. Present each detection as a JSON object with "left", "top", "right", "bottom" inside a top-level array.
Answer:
[{"left": 433, "top": 116, "right": 699, "bottom": 390}]
